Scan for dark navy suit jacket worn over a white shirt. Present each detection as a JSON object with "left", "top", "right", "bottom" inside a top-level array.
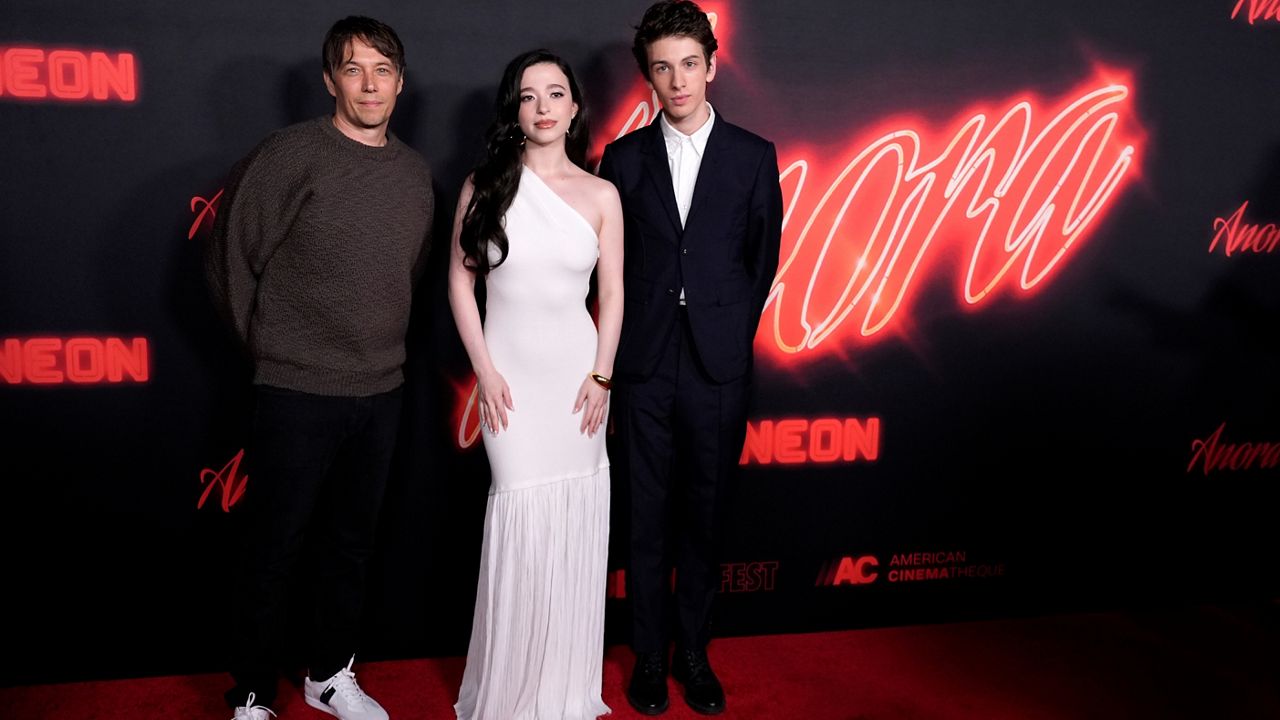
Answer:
[{"left": 600, "top": 111, "right": 782, "bottom": 383}]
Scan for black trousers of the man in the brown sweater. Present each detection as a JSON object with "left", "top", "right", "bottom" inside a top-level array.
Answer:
[{"left": 227, "top": 386, "right": 401, "bottom": 706}]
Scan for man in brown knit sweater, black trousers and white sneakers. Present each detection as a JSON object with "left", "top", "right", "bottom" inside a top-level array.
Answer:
[{"left": 205, "top": 17, "right": 434, "bottom": 720}]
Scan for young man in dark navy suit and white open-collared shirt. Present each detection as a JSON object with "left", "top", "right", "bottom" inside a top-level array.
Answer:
[{"left": 600, "top": 0, "right": 782, "bottom": 715}]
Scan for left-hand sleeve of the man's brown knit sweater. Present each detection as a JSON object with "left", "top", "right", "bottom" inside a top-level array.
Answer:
[{"left": 204, "top": 136, "right": 307, "bottom": 346}]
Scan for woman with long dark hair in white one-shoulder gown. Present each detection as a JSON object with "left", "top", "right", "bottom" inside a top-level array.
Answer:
[{"left": 449, "top": 50, "right": 622, "bottom": 720}]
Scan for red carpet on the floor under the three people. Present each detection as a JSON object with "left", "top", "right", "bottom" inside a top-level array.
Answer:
[{"left": 0, "top": 607, "right": 1280, "bottom": 720}]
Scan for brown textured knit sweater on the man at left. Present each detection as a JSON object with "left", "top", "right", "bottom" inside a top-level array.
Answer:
[{"left": 205, "top": 117, "right": 434, "bottom": 396}]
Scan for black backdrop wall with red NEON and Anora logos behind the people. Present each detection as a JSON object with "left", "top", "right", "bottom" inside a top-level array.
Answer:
[{"left": 0, "top": 0, "right": 1280, "bottom": 683}]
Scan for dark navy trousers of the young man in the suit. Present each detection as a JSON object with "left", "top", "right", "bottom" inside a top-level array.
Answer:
[{"left": 614, "top": 309, "right": 750, "bottom": 652}]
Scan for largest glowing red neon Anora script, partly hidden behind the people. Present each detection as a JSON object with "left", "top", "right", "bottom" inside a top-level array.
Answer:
[{"left": 454, "top": 5, "right": 1146, "bottom": 448}]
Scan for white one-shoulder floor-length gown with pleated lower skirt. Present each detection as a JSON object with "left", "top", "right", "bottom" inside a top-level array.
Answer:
[{"left": 454, "top": 168, "right": 609, "bottom": 720}]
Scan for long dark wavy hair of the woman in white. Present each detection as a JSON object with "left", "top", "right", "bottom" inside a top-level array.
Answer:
[{"left": 458, "top": 50, "right": 589, "bottom": 275}]
